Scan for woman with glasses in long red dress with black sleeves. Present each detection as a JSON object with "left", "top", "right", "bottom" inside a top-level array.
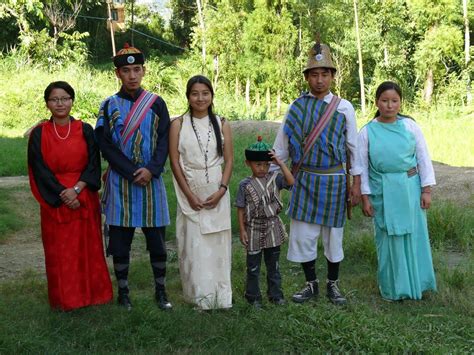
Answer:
[{"left": 28, "top": 81, "right": 112, "bottom": 311}]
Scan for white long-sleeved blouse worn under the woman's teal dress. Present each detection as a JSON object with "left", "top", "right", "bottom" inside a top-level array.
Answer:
[{"left": 356, "top": 118, "right": 436, "bottom": 195}]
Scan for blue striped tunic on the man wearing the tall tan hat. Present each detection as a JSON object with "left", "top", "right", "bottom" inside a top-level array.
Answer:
[{"left": 283, "top": 95, "right": 346, "bottom": 228}]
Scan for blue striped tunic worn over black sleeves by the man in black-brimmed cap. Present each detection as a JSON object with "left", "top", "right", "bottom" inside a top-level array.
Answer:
[{"left": 97, "top": 95, "right": 170, "bottom": 227}]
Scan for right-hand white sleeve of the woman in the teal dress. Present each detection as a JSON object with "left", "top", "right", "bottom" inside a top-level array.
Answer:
[{"left": 403, "top": 118, "right": 436, "bottom": 187}]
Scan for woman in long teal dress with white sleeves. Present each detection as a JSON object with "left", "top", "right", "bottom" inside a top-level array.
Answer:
[{"left": 358, "top": 81, "right": 436, "bottom": 301}]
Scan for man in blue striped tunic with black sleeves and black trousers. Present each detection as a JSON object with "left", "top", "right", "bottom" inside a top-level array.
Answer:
[{"left": 95, "top": 45, "right": 171, "bottom": 310}]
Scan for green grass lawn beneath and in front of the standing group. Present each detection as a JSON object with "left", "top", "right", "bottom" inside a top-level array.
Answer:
[{"left": 0, "top": 127, "right": 474, "bottom": 354}]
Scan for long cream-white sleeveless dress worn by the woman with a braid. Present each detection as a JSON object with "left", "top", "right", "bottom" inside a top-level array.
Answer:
[{"left": 173, "top": 114, "right": 232, "bottom": 309}]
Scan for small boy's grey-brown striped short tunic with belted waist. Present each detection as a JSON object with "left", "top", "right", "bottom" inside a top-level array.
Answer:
[{"left": 245, "top": 173, "right": 286, "bottom": 251}]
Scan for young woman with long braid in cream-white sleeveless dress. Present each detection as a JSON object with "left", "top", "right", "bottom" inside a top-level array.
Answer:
[{"left": 169, "top": 75, "right": 233, "bottom": 310}]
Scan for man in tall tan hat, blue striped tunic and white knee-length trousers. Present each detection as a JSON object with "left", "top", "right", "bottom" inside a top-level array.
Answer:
[{"left": 274, "top": 42, "right": 360, "bottom": 305}]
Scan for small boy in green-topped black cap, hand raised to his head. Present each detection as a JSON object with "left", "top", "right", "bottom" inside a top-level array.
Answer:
[{"left": 235, "top": 136, "right": 294, "bottom": 308}]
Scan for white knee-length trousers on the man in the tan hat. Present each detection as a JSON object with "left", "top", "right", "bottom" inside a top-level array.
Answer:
[{"left": 287, "top": 219, "right": 344, "bottom": 263}]
